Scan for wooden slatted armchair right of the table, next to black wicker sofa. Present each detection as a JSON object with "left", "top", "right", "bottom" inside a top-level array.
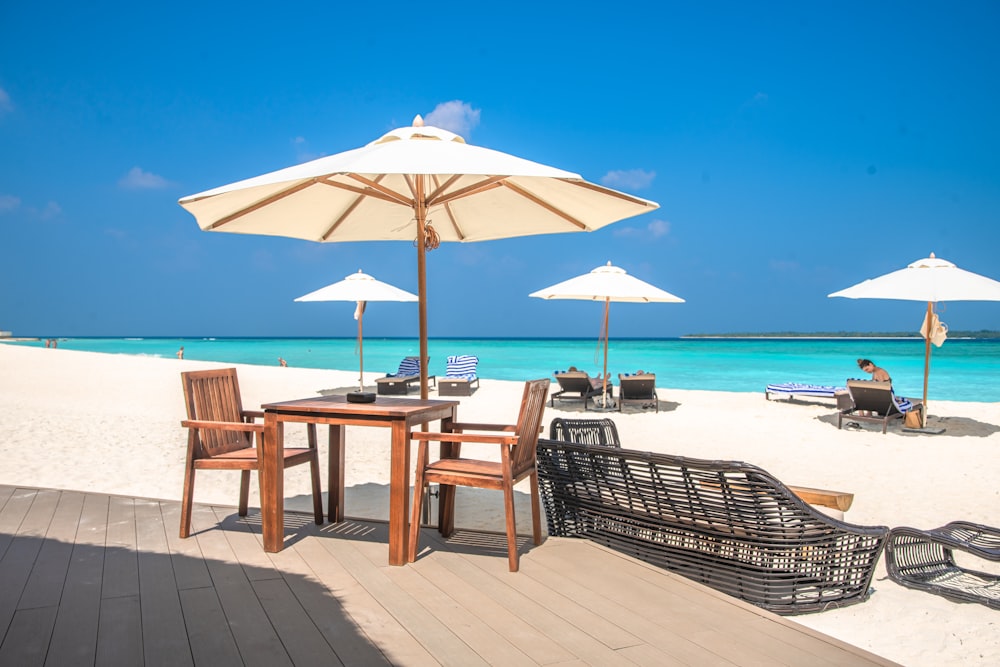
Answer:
[{"left": 407, "top": 379, "right": 550, "bottom": 572}]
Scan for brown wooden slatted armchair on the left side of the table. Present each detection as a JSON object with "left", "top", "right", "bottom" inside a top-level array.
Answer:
[{"left": 180, "top": 368, "right": 323, "bottom": 538}]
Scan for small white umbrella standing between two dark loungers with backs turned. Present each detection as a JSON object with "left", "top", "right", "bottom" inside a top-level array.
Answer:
[{"left": 528, "top": 262, "right": 684, "bottom": 405}]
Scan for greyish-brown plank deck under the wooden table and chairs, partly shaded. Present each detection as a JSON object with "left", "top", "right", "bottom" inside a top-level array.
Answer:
[{"left": 0, "top": 486, "right": 894, "bottom": 667}]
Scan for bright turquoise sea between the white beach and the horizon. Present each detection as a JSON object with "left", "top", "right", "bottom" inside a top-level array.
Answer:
[{"left": 11, "top": 337, "right": 1000, "bottom": 403}]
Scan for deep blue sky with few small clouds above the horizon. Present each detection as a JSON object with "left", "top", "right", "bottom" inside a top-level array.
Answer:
[{"left": 0, "top": 1, "right": 1000, "bottom": 337}]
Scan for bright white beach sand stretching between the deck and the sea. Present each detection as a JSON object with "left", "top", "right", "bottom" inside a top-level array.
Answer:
[{"left": 0, "top": 345, "right": 1000, "bottom": 665}]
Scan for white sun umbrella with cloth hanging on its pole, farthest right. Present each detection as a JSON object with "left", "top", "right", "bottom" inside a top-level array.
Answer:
[{"left": 828, "top": 253, "right": 1000, "bottom": 425}]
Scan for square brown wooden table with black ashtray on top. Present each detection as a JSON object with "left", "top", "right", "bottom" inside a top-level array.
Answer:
[{"left": 259, "top": 396, "right": 458, "bottom": 565}]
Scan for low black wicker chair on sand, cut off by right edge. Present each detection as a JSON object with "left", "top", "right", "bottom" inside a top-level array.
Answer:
[{"left": 885, "top": 521, "right": 1000, "bottom": 609}]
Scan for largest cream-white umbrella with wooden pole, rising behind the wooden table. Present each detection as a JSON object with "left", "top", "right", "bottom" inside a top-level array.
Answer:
[{"left": 179, "top": 116, "right": 657, "bottom": 398}]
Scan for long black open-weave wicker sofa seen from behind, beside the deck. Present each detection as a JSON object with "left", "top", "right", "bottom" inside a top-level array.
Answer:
[{"left": 538, "top": 439, "right": 889, "bottom": 614}]
